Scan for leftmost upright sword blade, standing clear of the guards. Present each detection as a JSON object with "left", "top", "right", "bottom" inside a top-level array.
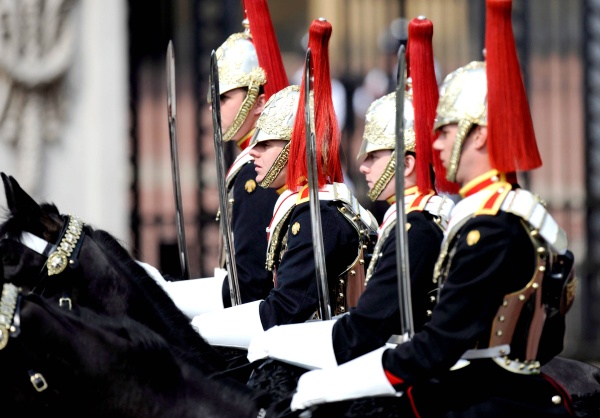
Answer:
[{"left": 167, "top": 41, "right": 190, "bottom": 279}]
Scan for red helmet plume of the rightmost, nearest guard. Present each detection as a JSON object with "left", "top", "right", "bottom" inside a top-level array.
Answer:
[{"left": 485, "top": 0, "right": 542, "bottom": 173}]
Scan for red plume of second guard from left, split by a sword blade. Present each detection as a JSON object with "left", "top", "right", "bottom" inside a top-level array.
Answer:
[{"left": 286, "top": 19, "right": 344, "bottom": 190}]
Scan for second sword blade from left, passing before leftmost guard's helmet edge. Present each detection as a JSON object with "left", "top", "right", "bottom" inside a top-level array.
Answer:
[{"left": 210, "top": 51, "right": 242, "bottom": 306}]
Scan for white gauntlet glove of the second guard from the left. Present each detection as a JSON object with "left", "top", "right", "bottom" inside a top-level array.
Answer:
[{"left": 192, "top": 300, "right": 263, "bottom": 349}]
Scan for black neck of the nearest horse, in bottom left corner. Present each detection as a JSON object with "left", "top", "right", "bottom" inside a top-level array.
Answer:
[{"left": 0, "top": 284, "right": 274, "bottom": 418}]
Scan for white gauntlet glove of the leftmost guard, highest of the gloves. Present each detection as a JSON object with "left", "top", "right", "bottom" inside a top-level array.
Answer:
[{"left": 163, "top": 268, "right": 227, "bottom": 319}]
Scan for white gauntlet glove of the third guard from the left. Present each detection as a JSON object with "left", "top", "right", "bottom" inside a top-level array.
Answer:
[{"left": 248, "top": 320, "right": 337, "bottom": 369}]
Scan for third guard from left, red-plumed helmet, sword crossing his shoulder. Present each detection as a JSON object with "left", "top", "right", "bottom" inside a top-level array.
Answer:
[{"left": 248, "top": 18, "right": 454, "bottom": 369}]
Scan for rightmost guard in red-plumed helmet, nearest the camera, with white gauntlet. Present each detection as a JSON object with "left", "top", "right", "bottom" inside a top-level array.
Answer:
[{"left": 291, "top": 0, "right": 573, "bottom": 417}]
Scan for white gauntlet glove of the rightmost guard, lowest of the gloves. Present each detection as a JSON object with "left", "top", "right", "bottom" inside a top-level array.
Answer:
[{"left": 291, "top": 346, "right": 402, "bottom": 411}]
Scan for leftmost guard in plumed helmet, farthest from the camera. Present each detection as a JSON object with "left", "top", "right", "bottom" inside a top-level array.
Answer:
[{"left": 157, "top": 0, "right": 288, "bottom": 318}]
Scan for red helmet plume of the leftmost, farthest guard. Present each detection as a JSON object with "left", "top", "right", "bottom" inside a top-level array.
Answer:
[{"left": 244, "top": 0, "right": 289, "bottom": 100}]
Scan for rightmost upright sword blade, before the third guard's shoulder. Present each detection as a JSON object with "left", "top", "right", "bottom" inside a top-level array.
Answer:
[{"left": 394, "top": 45, "right": 414, "bottom": 343}]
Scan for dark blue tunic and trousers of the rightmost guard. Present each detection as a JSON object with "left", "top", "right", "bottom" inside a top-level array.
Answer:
[{"left": 383, "top": 212, "right": 569, "bottom": 417}]
